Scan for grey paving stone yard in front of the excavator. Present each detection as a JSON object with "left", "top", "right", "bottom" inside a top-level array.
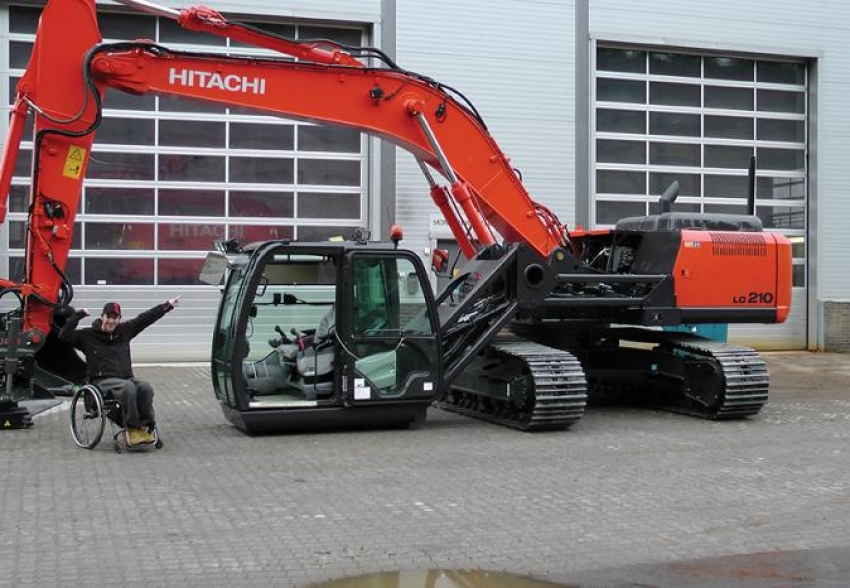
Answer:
[{"left": 0, "top": 353, "right": 850, "bottom": 588}]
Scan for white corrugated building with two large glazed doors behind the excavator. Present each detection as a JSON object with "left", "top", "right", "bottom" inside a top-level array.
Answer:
[{"left": 0, "top": 0, "right": 850, "bottom": 361}]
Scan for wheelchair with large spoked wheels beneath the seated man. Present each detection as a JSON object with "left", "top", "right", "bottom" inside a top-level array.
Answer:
[{"left": 70, "top": 384, "right": 162, "bottom": 453}]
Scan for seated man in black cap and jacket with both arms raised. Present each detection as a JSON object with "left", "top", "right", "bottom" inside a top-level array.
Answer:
[{"left": 59, "top": 296, "right": 180, "bottom": 445}]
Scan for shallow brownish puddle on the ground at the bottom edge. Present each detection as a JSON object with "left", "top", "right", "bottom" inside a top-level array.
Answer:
[{"left": 310, "top": 569, "right": 578, "bottom": 588}]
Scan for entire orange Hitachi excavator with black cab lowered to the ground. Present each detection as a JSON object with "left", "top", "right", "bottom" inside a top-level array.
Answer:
[{"left": 0, "top": 0, "right": 791, "bottom": 433}]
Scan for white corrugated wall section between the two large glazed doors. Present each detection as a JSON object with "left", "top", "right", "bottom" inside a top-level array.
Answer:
[{"left": 396, "top": 0, "right": 575, "bottom": 255}]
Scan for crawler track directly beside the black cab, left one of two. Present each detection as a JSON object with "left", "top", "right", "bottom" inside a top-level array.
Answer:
[{"left": 434, "top": 341, "right": 587, "bottom": 431}]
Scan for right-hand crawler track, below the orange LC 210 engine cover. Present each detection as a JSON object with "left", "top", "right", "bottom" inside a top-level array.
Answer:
[{"left": 668, "top": 336, "right": 770, "bottom": 420}]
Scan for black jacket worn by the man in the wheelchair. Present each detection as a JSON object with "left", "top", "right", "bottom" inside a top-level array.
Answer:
[{"left": 59, "top": 302, "right": 174, "bottom": 382}]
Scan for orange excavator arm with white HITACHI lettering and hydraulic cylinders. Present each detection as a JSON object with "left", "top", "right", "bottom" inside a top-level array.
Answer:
[{"left": 0, "top": 0, "right": 566, "bottom": 338}]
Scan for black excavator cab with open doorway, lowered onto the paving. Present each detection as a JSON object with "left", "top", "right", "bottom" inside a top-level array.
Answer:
[{"left": 202, "top": 241, "right": 442, "bottom": 433}]
